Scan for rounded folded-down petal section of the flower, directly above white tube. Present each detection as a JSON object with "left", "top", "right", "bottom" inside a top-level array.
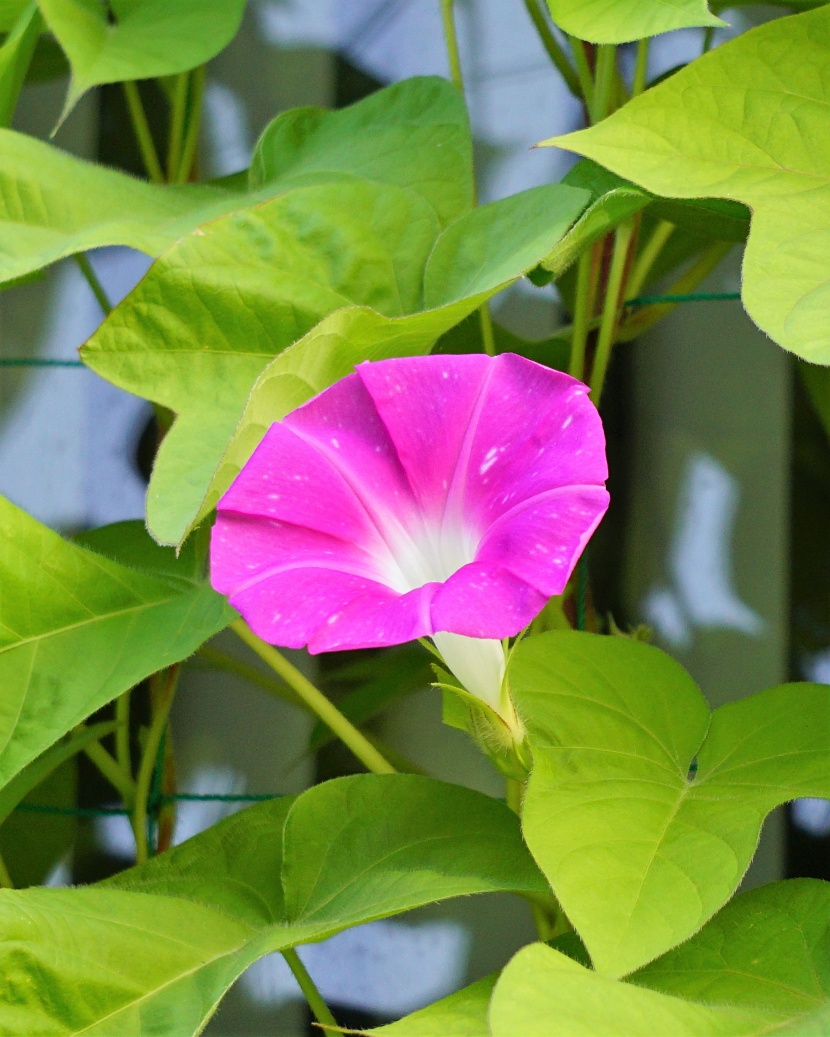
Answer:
[{"left": 433, "top": 562, "right": 547, "bottom": 638}]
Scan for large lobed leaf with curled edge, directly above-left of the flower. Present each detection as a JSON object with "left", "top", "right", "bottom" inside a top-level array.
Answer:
[{"left": 82, "top": 177, "right": 587, "bottom": 543}]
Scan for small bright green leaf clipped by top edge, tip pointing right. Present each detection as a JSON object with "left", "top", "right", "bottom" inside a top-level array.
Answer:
[{"left": 548, "top": 0, "right": 726, "bottom": 44}]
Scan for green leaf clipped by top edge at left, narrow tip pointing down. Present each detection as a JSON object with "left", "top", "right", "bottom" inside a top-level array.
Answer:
[{"left": 37, "top": 0, "right": 245, "bottom": 116}]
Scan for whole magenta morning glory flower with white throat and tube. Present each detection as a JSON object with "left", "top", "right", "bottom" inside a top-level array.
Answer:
[{"left": 211, "top": 354, "right": 608, "bottom": 712}]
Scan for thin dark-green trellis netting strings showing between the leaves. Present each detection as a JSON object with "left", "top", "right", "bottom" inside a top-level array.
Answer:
[{"left": 0, "top": 291, "right": 741, "bottom": 825}]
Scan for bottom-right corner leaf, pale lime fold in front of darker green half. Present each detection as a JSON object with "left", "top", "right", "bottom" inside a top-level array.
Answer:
[{"left": 489, "top": 878, "right": 830, "bottom": 1037}]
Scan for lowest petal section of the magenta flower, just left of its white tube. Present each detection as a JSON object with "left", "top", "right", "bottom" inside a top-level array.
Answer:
[{"left": 308, "top": 584, "right": 440, "bottom": 654}]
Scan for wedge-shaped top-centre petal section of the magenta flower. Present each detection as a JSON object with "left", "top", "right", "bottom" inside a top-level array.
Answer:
[{"left": 357, "top": 355, "right": 493, "bottom": 516}]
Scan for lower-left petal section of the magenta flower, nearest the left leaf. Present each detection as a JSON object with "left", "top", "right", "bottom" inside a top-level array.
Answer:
[{"left": 229, "top": 568, "right": 398, "bottom": 648}]
